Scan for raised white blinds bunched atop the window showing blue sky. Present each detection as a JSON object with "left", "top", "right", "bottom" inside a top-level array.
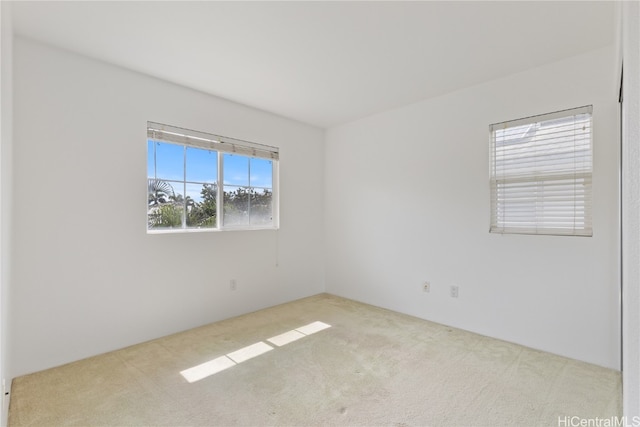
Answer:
[{"left": 147, "top": 122, "right": 279, "bottom": 160}]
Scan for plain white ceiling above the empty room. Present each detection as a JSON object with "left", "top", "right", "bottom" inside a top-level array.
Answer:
[{"left": 13, "top": 1, "right": 614, "bottom": 128}]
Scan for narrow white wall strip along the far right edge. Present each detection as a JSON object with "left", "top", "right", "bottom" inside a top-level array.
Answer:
[{"left": 621, "top": 2, "right": 640, "bottom": 420}]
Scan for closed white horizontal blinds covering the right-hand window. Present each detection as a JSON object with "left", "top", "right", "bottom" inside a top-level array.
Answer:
[{"left": 490, "top": 106, "right": 593, "bottom": 236}]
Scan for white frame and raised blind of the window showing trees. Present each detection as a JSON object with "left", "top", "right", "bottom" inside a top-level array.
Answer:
[{"left": 147, "top": 121, "right": 280, "bottom": 234}]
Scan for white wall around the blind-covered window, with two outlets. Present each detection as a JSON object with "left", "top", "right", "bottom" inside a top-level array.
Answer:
[{"left": 325, "top": 47, "right": 620, "bottom": 368}]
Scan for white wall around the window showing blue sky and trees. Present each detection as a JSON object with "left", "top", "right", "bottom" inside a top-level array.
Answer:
[{"left": 10, "top": 37, "right": 324, "bottom": 376}]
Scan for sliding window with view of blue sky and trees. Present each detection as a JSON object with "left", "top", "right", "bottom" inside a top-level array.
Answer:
[{"left": 147, "top": 122, "right": 279, "bottom": 231}]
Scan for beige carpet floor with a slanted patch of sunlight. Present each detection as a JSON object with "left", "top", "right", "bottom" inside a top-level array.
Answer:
[{"left": 9, "top": 294, "right": 622, "bottom": 426}]
